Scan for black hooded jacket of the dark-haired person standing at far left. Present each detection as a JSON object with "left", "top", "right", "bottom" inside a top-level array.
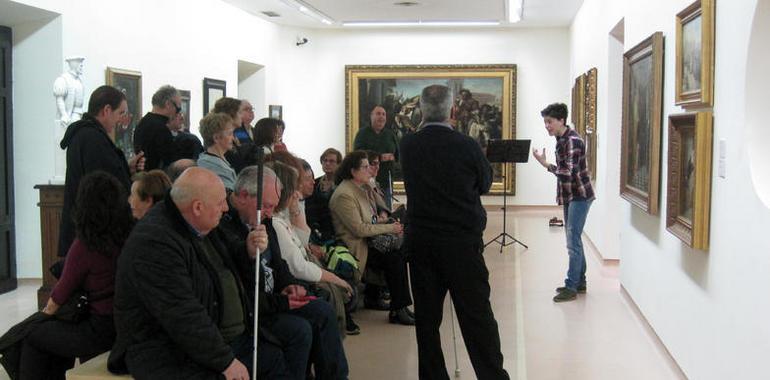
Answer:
[{"left": 58, "top": 114, "right": 131, "bottom": 256}]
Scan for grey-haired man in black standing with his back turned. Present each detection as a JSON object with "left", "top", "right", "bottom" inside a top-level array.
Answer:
[{"left": 401, "top": 85, "right": 509, "bottom": 380}]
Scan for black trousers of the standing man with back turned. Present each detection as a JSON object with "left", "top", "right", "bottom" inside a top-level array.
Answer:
[{"left": 407, "top": 236, "right": 509, "bottom": 380}]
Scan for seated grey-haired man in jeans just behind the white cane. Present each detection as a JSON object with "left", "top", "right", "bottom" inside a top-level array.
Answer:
[{"left": 216, "top": 163, "right": 348, "bottom": 379}]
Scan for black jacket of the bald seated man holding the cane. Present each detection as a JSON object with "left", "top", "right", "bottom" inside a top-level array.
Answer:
[{"left": 108, "top": 196, "right": 252, "bottom": 378}]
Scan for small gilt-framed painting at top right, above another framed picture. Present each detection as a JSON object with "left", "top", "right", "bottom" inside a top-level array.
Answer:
[{"left": 676, "top": 0, "right": 715, "bottom": 109}]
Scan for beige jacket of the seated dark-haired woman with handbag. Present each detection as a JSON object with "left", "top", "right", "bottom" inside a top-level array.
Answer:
[{"left": 329, "top": 179, "right": 393, "bottom": 280}]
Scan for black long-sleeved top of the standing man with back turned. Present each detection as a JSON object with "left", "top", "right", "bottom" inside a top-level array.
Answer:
[{"left": 401, "top": 124, "right": 492, "bottom": 239}]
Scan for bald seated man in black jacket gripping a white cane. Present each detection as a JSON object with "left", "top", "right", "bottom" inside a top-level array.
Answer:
[{"left": 109, "top": 168, "right": 267, "bottom": 379}]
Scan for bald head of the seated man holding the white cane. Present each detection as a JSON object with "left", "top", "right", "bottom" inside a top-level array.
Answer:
[{"left": 171, "top": 167, "right": 227, "bottom": 235}]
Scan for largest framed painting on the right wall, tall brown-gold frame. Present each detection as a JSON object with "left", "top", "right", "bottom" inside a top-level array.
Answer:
[{"left": 620, "top": 32, "right": 663, "bottom": 215}]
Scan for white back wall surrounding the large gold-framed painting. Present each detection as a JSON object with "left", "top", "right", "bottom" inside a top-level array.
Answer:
[{"left": 268, "top": 28, "right": 570, "bottom": 205}]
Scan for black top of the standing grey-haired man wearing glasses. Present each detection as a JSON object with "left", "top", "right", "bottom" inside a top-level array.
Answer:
[{"left": 134, "top": 112, "right": 178, "bottom": 171}]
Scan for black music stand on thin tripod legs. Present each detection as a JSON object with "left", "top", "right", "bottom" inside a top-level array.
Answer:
[{"left": 484, "top": 140, "right": 532, "bottom": 253}]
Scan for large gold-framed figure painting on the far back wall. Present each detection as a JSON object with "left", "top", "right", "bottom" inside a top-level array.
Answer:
[{"left": 345, "top": 64, "right": 516, "bottom": 194}]
